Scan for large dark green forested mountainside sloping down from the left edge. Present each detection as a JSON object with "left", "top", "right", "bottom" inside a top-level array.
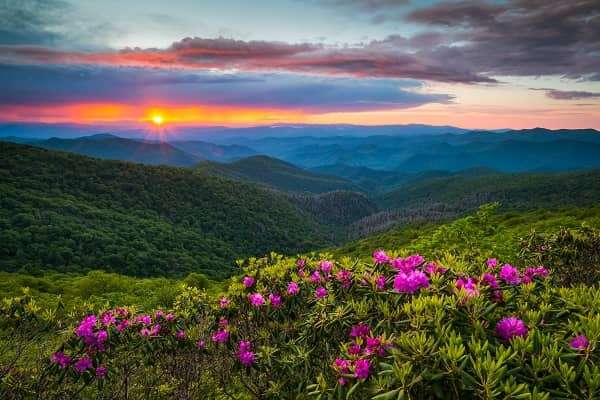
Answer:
[{"left": 0, "top": 142, "right": 331, "bottom": 277}]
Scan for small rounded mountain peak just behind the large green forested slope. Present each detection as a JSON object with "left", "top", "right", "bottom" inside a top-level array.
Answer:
[{"left": 197, "top": 156, "right": 356, "bottom": 193}]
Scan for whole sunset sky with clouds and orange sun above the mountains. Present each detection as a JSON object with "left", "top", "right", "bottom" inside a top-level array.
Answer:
[{"left": 0, "top": 0, "right": 600, "bottom": 129}]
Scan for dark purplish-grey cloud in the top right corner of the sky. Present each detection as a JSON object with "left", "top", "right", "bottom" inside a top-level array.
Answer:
[{"left": 408, "top": 0, "right": 600, "bottom": 80}]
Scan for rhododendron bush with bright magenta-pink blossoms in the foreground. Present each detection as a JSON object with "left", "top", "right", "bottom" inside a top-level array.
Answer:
[{"left": 5, "top": 249, "right": 600, "bottom": 399}]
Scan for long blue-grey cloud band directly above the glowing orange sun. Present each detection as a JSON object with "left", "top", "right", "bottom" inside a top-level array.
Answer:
[{"left": 0, "top": 65, "right": 452, "bottom": 113}]
